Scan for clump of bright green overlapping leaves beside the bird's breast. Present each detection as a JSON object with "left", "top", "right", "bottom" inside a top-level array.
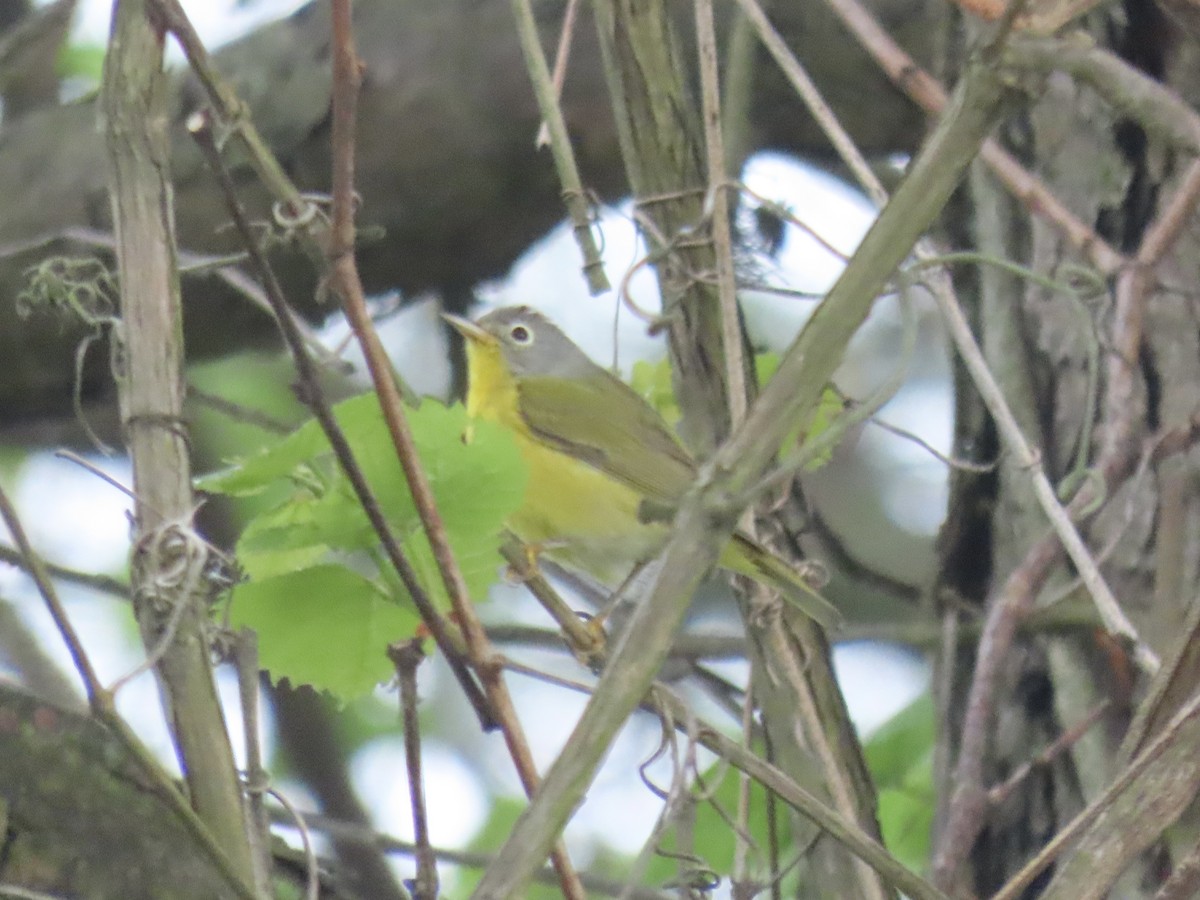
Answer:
[{"left": 207, "top": 394, "right": 528, "bottom": 698}]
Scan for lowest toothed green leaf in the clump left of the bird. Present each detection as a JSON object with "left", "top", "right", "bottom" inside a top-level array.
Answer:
[{"left": 230, "top": 565, "right": 418, "bottom": 697}]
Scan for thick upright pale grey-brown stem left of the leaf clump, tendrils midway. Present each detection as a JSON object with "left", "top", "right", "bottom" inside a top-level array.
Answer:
[{"left": 103, "top": 0, "right": 253, "bottom": 884}]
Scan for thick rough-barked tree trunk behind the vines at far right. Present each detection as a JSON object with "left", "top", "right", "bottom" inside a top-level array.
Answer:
[{"left": 940, "top": 2, "right": 1200, "bottom": 898}]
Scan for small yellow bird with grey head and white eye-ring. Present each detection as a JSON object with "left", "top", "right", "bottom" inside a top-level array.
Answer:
[{"left": 444, "top": 306, "right": 841, "bottom": 626}]
